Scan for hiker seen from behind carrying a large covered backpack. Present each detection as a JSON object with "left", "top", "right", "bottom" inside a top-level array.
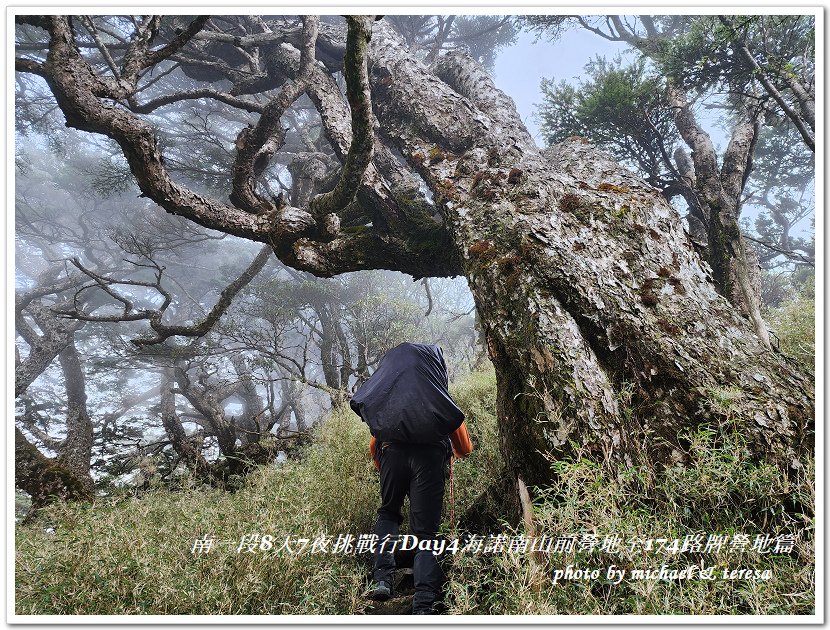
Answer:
[{"left": 350, "top": 343, "right": 473, "bottom": 615}]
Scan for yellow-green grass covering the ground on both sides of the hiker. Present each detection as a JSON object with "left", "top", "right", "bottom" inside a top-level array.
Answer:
[{"left": 15, "top": 372, "right": 815, "bottom": 615}]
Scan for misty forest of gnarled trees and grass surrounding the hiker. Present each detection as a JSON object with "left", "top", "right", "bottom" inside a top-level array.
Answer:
[{"left": 10, "top": 15, "right": 821, "bottom": 615}]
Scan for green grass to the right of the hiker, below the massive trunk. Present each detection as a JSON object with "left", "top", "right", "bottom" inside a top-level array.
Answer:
[{"left": 449, "top": 427, "right": 815, "bottom": 615}]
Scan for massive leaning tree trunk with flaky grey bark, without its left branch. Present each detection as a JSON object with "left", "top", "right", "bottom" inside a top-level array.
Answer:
[{"left": 373, "top": 33, "right": 814, "bottom": 483}]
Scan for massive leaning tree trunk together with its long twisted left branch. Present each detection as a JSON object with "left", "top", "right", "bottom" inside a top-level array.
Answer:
[{"left": 18, "top": 17, "right": 814, "bottom": 494}]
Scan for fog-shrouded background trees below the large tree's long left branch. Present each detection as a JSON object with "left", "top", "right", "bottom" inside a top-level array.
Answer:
[{"left": 17, "top": 123, "right": 474, "bottom": 496}]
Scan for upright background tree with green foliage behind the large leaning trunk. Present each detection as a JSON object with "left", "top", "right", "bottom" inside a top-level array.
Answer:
[{"left": 524, "top": 16, "right": 809, "bottom": 330}]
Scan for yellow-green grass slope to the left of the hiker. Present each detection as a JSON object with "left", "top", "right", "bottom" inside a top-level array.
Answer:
[{"left": 15, "top": 409, "right": 378, "bottom": 615}]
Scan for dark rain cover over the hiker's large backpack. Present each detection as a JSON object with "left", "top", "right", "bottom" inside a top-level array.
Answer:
[{"left": 349, "top": 343, "right": 464, "bottom": 444}]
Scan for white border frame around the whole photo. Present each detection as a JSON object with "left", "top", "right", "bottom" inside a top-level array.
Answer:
[{"left": 4, "top": 0, "right": 825, "bottom": 626}]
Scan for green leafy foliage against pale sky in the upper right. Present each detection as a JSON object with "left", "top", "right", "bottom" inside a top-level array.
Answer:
[{"left": 536, "top": 15, "right": 815, "bottom": 268}]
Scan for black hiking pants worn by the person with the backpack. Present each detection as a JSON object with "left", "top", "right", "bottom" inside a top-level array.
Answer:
[{"left": 374, "top": 440, "right": 452, "bottom": 612}]
